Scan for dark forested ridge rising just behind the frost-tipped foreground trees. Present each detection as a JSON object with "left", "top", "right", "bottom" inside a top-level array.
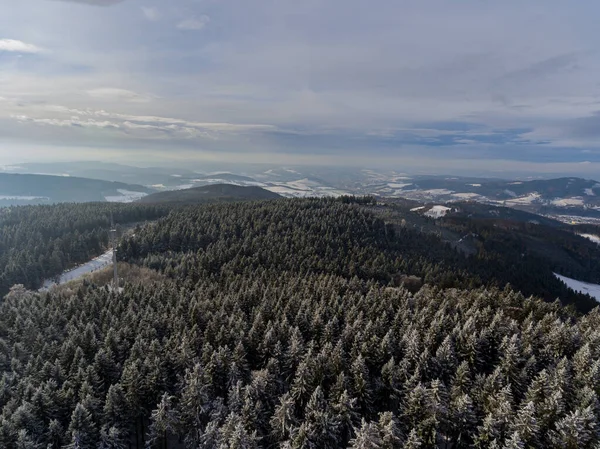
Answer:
[{"left": 120, "top": 198, "right": 600, "bottom": 311}]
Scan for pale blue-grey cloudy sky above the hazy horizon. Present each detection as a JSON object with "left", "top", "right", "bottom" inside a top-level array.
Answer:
[{"left": 0, "top": 0, "right": 600, "bottom": 177}]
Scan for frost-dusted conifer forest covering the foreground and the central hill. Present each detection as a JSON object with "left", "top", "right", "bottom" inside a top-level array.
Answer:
[{"left": 0, "top": 199, "right": 600, "bottom": 449}]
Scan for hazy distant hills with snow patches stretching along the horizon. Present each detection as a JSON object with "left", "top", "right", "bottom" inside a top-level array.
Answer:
[{"left": 0, "top": 162, "right": 600, "bottom": 219}]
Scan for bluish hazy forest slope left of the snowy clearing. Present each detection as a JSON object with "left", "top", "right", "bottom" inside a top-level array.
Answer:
[{"left": 0, "top": 203, "right": 169, "bottom": 297}]
